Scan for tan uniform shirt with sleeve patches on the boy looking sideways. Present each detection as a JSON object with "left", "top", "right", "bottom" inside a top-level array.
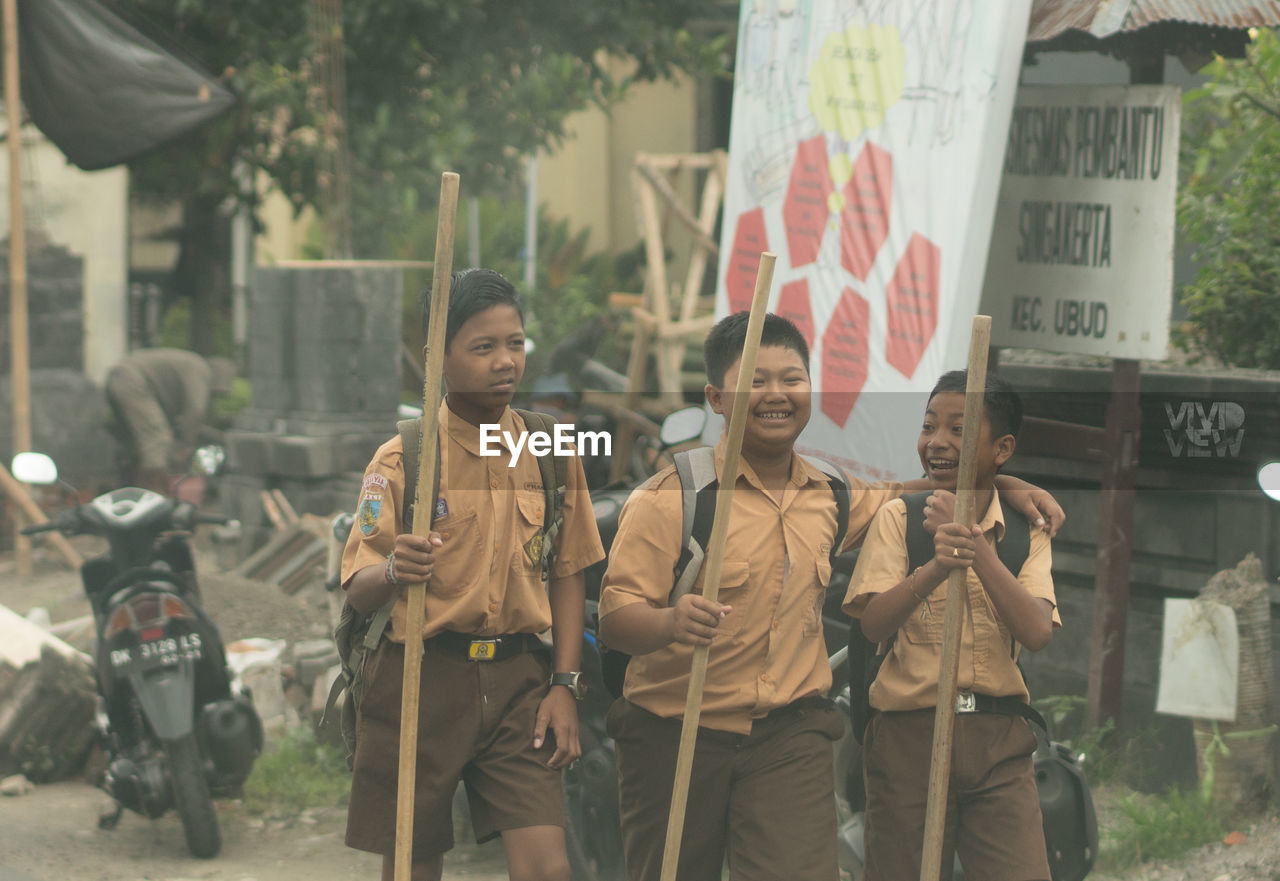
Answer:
[{"left": 342, "top": 402, "right": 604, "bottom": 643}]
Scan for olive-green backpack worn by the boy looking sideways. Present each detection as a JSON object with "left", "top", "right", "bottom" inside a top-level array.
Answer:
[{"left": 320, "top": 410, "right": 568, "bottom": 768}]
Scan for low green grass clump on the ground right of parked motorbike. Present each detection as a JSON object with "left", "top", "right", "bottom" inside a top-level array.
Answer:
[{"left": 244, "top": 730, "right": 351, "bottom": 817}]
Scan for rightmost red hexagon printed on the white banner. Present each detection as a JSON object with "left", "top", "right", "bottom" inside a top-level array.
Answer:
[{"left": 884, "top": 233, "right": 942, "bottom": 379}]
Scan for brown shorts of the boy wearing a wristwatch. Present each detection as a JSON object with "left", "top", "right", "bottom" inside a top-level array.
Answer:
[{"left": 347, "top": 640, "right": 564, "bottom": 862}]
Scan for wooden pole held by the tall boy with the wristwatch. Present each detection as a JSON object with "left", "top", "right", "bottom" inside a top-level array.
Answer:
[{"left": 396, "top": 172, "right": 458, "bottom": 881}]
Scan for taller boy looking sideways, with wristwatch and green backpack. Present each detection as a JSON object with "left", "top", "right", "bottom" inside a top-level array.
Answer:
[{"left": 342, "top": 269, "right": 604, "bottom": 881}]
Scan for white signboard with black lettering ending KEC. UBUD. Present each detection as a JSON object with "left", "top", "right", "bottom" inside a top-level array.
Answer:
[{"left": 982, "top": 86, "right": 1181, "bottom": 360}]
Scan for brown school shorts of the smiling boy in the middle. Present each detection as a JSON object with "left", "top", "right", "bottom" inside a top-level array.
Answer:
[{"left": 607, "top": 698, "right": 845, "bottom": 881}]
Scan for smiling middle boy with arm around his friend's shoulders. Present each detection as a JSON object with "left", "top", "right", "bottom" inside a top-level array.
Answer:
[{"left": 600, "top": 312, "right": 1061, "bottom": 881}]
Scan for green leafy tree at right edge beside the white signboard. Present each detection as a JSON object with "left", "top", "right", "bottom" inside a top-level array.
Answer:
[{"left": 1175, "top": 29, "right": 1280, "bottom": 369}]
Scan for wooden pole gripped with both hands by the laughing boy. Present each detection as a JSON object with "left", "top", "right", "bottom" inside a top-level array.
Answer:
[{"left": 920, "top": 315, "right": 991, "bottom": 881}]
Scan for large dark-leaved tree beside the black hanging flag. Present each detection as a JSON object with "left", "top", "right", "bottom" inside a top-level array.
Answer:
[{"left": 122, "top": 0, "right": 722, "bottom": 351}]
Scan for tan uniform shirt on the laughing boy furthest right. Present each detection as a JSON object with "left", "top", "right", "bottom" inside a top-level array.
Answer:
[{"left": 844, "top": 493, "right": 1062, "bottom": 711}]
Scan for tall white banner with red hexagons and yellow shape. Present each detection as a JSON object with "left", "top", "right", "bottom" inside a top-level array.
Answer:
[{"left": 714, "top": 0, "right": 1030, "bottom": 479}]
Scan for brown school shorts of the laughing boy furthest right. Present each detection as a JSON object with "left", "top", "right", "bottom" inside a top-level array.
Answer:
[{"left": 863, "top": 708, "right": 1050, "bottom": 881}]
